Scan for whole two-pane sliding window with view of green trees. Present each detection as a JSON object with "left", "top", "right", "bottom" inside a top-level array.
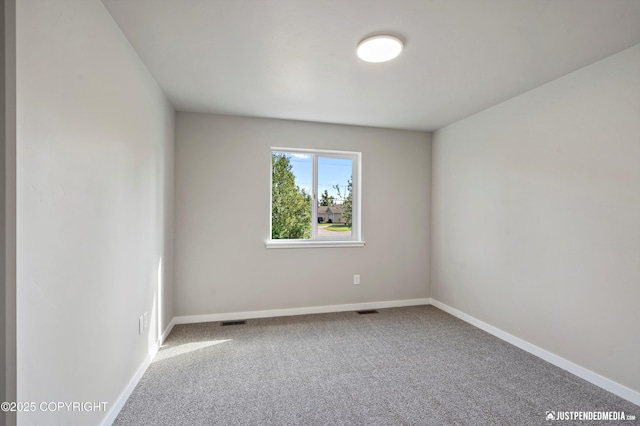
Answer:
[{"left": 267, "top": 148, "right": 364, "bottom": 248}]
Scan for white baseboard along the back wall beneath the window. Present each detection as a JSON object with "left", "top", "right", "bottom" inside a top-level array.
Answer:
[{"left": 174, "top": 298, "right": 430, "bottom": 324}]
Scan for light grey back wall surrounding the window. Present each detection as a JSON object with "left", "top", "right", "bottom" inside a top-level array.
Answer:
[{"left": 175, "top": 113, "right": 431, "bottom": 315}]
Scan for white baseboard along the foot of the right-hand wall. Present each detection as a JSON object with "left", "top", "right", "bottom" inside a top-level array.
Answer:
[{"left": 430, "top": 298, "right": 640, "bottom": 406}]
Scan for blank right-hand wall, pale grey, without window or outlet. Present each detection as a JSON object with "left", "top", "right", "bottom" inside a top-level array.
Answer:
[{"left": 431, "top": 45, "right": 640, "bottom": 391}]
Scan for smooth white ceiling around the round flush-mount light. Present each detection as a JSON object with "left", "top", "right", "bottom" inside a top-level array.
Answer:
[{"left": 103, "top": 0, "right": 640, "bottom": 131}]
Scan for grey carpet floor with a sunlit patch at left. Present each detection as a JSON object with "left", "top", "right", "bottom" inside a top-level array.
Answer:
[{"left": 114, "top": 306, "right": 640, "bottom": 426}]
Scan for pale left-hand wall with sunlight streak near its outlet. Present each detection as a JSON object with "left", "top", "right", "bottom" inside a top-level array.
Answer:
[{"left": 17, "top": 0, "right": 174, "bottom": 425}]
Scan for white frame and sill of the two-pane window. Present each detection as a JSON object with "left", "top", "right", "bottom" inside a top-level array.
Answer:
[{"left": 266, "top": 147, "right": 365, "bottom": 248}]
